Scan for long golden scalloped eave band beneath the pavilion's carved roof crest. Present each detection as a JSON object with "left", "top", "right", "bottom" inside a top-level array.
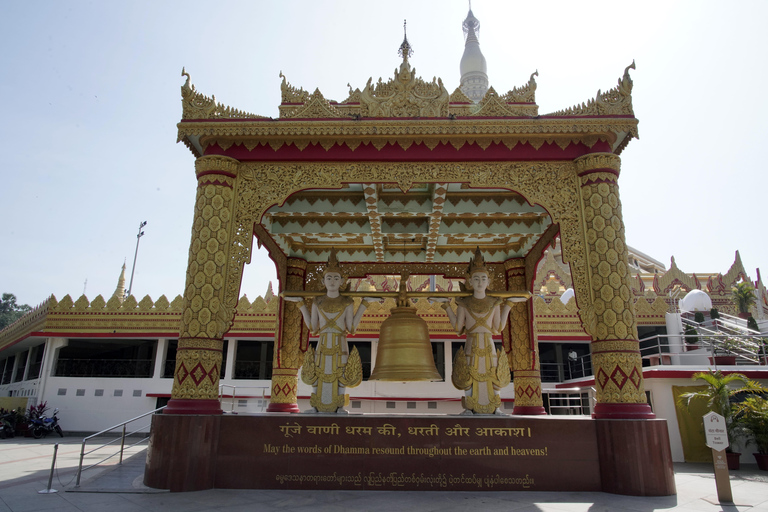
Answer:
[{"left": 177, "top": 116, "right": 638, "bottom": 156}]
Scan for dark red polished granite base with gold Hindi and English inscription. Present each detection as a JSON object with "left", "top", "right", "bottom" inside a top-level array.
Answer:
[{"left": 144, "top": 414, "right": 674, "bottom": 495}]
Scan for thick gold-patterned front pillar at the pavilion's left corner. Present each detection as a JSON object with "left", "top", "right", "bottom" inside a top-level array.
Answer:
[{"left": 165, "top": 156, "right": 246, "bottom": 414}]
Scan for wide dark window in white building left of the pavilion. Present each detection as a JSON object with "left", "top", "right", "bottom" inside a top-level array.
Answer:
[{"left": 54, "top": 340, "right": 157, "bottom": 378}]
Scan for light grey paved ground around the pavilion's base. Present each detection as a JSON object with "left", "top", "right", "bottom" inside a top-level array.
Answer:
[{"left": 0, "top": 437, "right": 768, "bottom": 512}]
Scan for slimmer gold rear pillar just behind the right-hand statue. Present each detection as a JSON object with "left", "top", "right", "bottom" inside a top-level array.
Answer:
[{"left": 504, "top": 260, "right": 546, "bottom": 415}]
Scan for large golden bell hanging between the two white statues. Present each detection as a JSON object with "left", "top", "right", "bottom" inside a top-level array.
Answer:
[{"left": 368, "top": 307, "right": 443, "bottom": 381}]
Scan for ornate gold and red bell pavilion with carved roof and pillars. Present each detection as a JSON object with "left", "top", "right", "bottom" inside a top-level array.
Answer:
[{"left": 148, "top": 55, "right": 674, "bottom": 494}]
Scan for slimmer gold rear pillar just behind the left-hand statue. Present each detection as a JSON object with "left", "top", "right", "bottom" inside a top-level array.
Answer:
[{"left": 267, "top": 258, "right": 309, "bottom": 412}]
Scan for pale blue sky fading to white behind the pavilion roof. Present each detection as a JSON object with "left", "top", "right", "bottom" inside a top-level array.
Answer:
[{"left": 0, "top": 0, "right": 768, "bottom": 306}]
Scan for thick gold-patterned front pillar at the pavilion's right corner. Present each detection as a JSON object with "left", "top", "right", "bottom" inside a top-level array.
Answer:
[{"left": 575, "top": 153, "right": 655, "bottom": 419}]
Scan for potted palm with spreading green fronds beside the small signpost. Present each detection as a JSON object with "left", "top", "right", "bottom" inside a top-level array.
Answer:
[{"left": 678, "top": 370, "right": 768, "bottom": 469}]
